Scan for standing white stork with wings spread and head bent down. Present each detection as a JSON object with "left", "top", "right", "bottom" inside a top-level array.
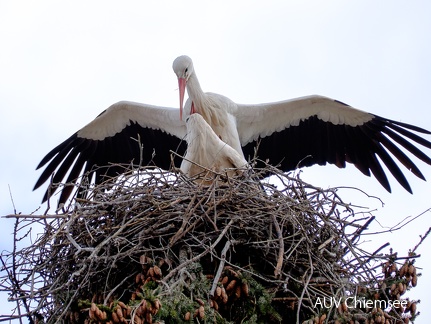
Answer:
[{"left": 34, "top": 56, "right": 431, "bottom": 204}]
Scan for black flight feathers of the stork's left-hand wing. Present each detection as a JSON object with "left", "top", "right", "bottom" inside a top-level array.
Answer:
[{"left": 34, "top": 122, "right": 186, "bottom": 204}]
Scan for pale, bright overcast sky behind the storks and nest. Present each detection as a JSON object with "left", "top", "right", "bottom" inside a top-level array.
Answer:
[{"left": 0, "top": 0, "right": 431, "bottom": 323}]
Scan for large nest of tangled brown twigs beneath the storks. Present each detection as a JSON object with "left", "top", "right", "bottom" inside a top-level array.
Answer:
[{"left": 1, "top": 166, "right": 422, "bottom": 323}]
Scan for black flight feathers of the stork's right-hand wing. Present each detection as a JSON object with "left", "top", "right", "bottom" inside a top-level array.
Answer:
[{"left": 243, "top": 116, "right": 431, "bottom": 193}]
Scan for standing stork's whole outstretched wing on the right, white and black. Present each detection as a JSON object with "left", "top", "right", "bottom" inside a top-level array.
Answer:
[{"left": 235, "top": 96, "right": 431, "bottom": 193}]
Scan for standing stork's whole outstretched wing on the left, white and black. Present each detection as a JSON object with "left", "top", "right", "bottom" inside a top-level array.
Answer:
[{"left": 34, "top": 101, "right": 186, "bottom": 204}]
